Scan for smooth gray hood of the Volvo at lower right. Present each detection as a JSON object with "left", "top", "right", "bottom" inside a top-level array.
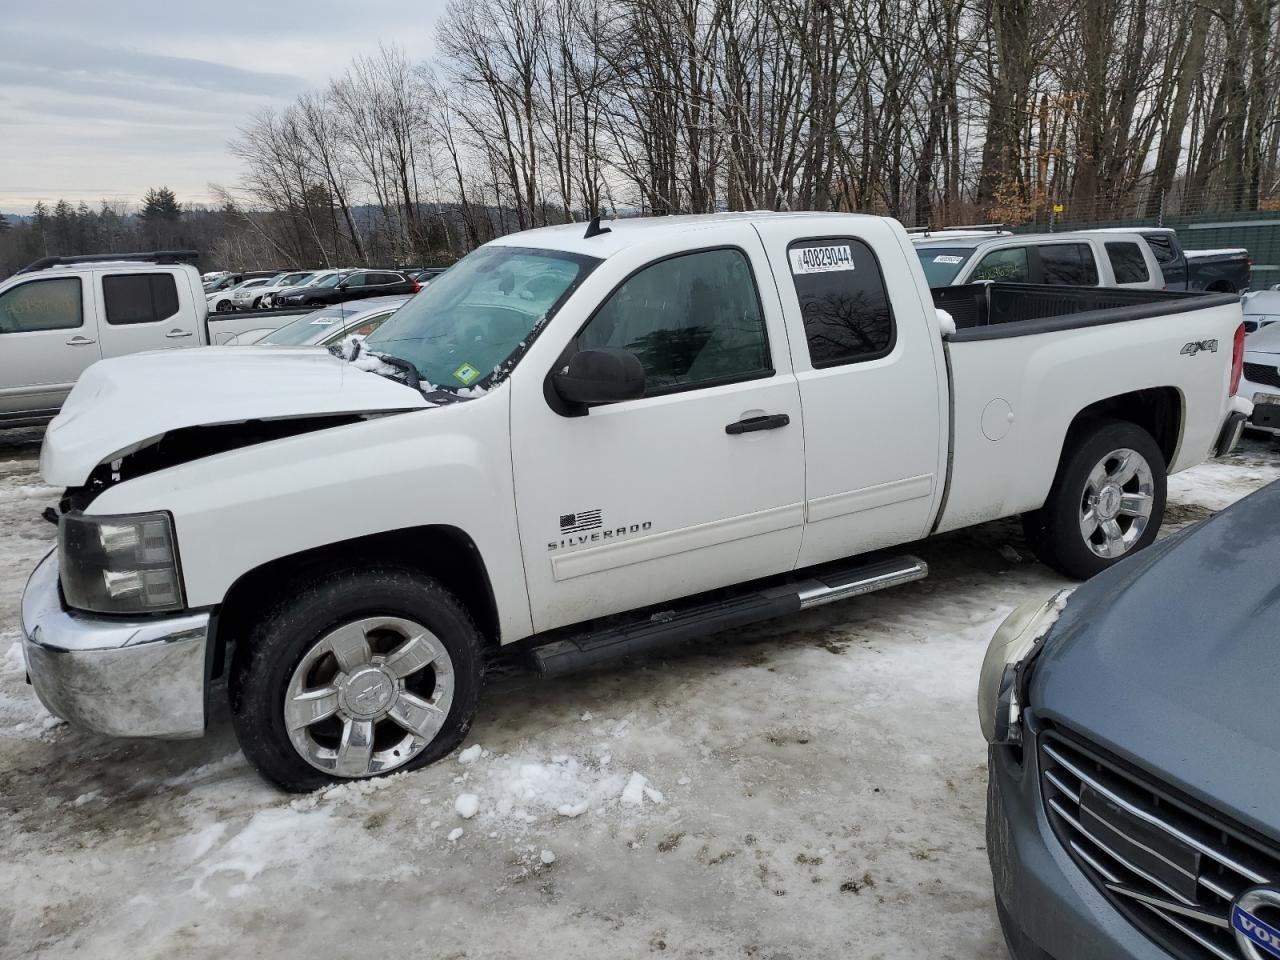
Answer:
[{"left": 1029, "top": 483, "right": 1280, "bottom": 840}]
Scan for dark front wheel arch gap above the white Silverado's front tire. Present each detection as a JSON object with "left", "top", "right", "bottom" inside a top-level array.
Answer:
[{"left": 211, "top": 524, "right": 500, "bottom": 676}]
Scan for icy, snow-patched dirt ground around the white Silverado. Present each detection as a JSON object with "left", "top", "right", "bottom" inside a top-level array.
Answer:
[{"left": 0, "top": 436, "right": 1280, "bottom": 960}]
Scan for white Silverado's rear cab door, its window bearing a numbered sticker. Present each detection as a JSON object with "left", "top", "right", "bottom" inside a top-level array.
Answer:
[{"left": 756, "top": 218, "right": 947, "bottom": 566}]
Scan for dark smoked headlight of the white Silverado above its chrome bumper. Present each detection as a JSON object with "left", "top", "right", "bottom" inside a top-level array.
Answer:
[{"left": 58, "top": 512, "right": 184, "bottom": 613}]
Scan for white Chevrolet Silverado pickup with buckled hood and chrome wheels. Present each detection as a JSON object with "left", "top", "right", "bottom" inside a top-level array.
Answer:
[{"left": 22, "top": 214, "right": 1249, "bottom": 790}]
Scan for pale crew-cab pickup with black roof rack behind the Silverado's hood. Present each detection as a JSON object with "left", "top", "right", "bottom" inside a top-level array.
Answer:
[{"left": 0, "top": 251, "right": 307, "bottom": 428}]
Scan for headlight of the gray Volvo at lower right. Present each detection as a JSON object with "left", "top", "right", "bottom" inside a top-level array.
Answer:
[{"left": 978, "top": 590, "right": 1071, "bottom": 744}]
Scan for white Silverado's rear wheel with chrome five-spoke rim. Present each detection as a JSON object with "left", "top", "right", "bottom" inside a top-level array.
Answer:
[{"left": 1023, "top": 420, "right": 1167, "bottom": 580}]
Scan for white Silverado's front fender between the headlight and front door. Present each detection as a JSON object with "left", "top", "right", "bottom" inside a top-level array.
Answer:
[{"left": 88, "top": 387, "right": 532, "bottom": 641}]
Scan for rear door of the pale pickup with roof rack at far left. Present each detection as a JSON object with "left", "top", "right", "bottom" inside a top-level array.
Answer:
[{"left": 95, "top": 269, "right": 202, "bottom": 357}]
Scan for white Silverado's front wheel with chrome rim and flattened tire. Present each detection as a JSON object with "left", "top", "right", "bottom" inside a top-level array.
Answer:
[{"left": 229, "top": 567, "right": 484, "bottom": 792}]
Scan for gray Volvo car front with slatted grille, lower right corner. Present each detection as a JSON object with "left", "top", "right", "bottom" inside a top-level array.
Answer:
[{"left": 978, "top": 483, "right": 1280, "bottom": 960}]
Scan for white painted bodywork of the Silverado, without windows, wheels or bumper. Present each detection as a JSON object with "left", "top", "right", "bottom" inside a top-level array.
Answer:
[{"left": 41, "top": 214, "right": 1240, "bottom": 643}]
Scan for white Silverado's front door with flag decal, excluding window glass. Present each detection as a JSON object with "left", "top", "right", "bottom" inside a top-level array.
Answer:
[{"left": 512, "top": 221, "right": 805, "bottom": 630}]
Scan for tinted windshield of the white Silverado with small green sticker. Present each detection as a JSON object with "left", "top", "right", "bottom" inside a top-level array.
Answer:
[{"left": 367, "top": 246, "right": 600, "bottom": 390}]
